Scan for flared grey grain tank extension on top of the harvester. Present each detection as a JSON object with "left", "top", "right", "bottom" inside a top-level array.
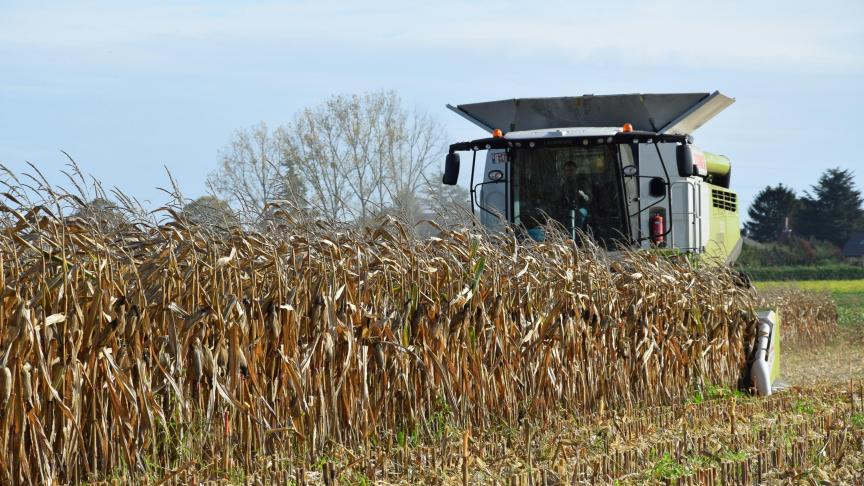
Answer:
[{"left": 448, "top": 91, "right": 735, "bottom": 135}]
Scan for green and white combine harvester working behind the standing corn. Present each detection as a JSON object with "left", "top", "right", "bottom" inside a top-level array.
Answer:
[{"left": 443, "top": 92, "right": 780, "bottom": 395}]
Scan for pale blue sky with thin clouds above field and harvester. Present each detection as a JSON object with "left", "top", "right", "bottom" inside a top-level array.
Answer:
[{"left": 0, "top": 0, "right": 864, "bottom": 214}]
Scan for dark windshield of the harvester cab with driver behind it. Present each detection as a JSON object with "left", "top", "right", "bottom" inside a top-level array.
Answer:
[{"left": 512, "top": 145, "right": 625, "bottom": 247}]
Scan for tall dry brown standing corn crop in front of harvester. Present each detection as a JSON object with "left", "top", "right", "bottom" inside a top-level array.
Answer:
[{"left": 0, "top": 191, "right": 840, "bottom": 484}]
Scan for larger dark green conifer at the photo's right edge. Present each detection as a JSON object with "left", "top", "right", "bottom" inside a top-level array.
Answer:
[{"left": 796, "top": 167, "right": 864, "bottom": 246}]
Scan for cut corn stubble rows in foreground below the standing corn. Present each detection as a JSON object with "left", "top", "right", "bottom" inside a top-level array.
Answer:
[{"left": 66, "top": 382, "right": 864, "bottom": 485}]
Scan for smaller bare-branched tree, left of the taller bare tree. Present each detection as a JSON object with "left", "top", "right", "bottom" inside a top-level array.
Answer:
[{"left": 207, "top": 122, "right": 305, "bottom": 221}]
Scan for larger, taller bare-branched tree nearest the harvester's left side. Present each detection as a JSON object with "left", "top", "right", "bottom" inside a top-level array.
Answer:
[{"left": 280, "top": 91, "right": 443, "bottom": 221}]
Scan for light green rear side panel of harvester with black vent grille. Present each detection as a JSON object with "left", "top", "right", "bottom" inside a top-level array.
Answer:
[{"left": 703, "top": 184, "right": 741, "bottom": 263}]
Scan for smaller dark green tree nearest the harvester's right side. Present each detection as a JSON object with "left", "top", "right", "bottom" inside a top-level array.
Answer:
[{"left": 744, "top": 184, "right": 798, "bottom": 242}]
